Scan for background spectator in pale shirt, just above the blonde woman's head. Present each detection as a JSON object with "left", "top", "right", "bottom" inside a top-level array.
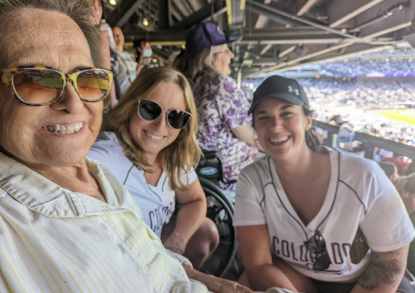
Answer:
[{"left": 112, "top": 27, "right": 141, "bottom": 97}]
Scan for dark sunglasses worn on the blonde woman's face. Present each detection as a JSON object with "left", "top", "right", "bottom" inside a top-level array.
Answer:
[{"left": 138, "top": 100, "right": 192, "bottom": 129}]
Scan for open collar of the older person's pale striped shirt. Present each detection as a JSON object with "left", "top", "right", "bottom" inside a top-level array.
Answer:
[{"left": 0, "top": 153, "right": 135, "bottom": 218}]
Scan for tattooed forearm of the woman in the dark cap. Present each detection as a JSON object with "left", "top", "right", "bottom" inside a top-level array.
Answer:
[{"left": 351, "top": 245, "right": 409, "bottom": 293}]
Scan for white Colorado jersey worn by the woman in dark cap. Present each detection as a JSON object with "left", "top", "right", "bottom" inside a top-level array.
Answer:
[{"left": 234, "top": 149, "right": 415, "bottom": 282}]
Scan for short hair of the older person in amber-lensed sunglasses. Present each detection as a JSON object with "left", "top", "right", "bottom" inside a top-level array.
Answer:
[{"left": 0, "top": 0, "right": 101, "bottom": 68}]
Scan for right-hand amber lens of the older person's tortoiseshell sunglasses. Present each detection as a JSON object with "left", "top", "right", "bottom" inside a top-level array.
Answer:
[{"left": 76, "top": 69, "right": 110, "bottom": 101}]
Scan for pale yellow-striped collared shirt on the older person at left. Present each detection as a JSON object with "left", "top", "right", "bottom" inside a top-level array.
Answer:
[{"left": 0, "top": 153, "right": 208, "bottom": 293}]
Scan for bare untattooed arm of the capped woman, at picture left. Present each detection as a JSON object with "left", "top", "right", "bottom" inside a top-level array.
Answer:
[{"left": 237, "top": 225, "right": 312, "bottom": 292}]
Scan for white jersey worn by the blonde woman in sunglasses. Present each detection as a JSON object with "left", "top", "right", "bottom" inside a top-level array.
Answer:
[{"left": 88, "top": 131, "right": 197, "bottom": 237}]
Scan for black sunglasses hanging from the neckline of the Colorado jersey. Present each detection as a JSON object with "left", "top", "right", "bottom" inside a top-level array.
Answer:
[{"left": 304, "top": 230, "right": 331, "bottom": 271}]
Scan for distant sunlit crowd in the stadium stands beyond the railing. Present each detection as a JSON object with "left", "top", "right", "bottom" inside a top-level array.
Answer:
[{"left": 242, "top": 77, "right": 415, "bottom": 145}]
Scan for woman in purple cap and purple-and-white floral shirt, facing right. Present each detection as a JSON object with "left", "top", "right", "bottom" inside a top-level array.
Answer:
[{"left": 174, "top": 22, "right": 259, "bottom": 191}]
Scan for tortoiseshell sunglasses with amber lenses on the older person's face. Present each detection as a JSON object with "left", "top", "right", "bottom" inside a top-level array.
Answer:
[{"left": 0, "top": 65, "right": 113, "bottom": 106}]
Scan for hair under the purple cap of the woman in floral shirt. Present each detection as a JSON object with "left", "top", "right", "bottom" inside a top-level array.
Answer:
[{"left": 173, "top": 47, "right": 214, "bottom": 82}]
